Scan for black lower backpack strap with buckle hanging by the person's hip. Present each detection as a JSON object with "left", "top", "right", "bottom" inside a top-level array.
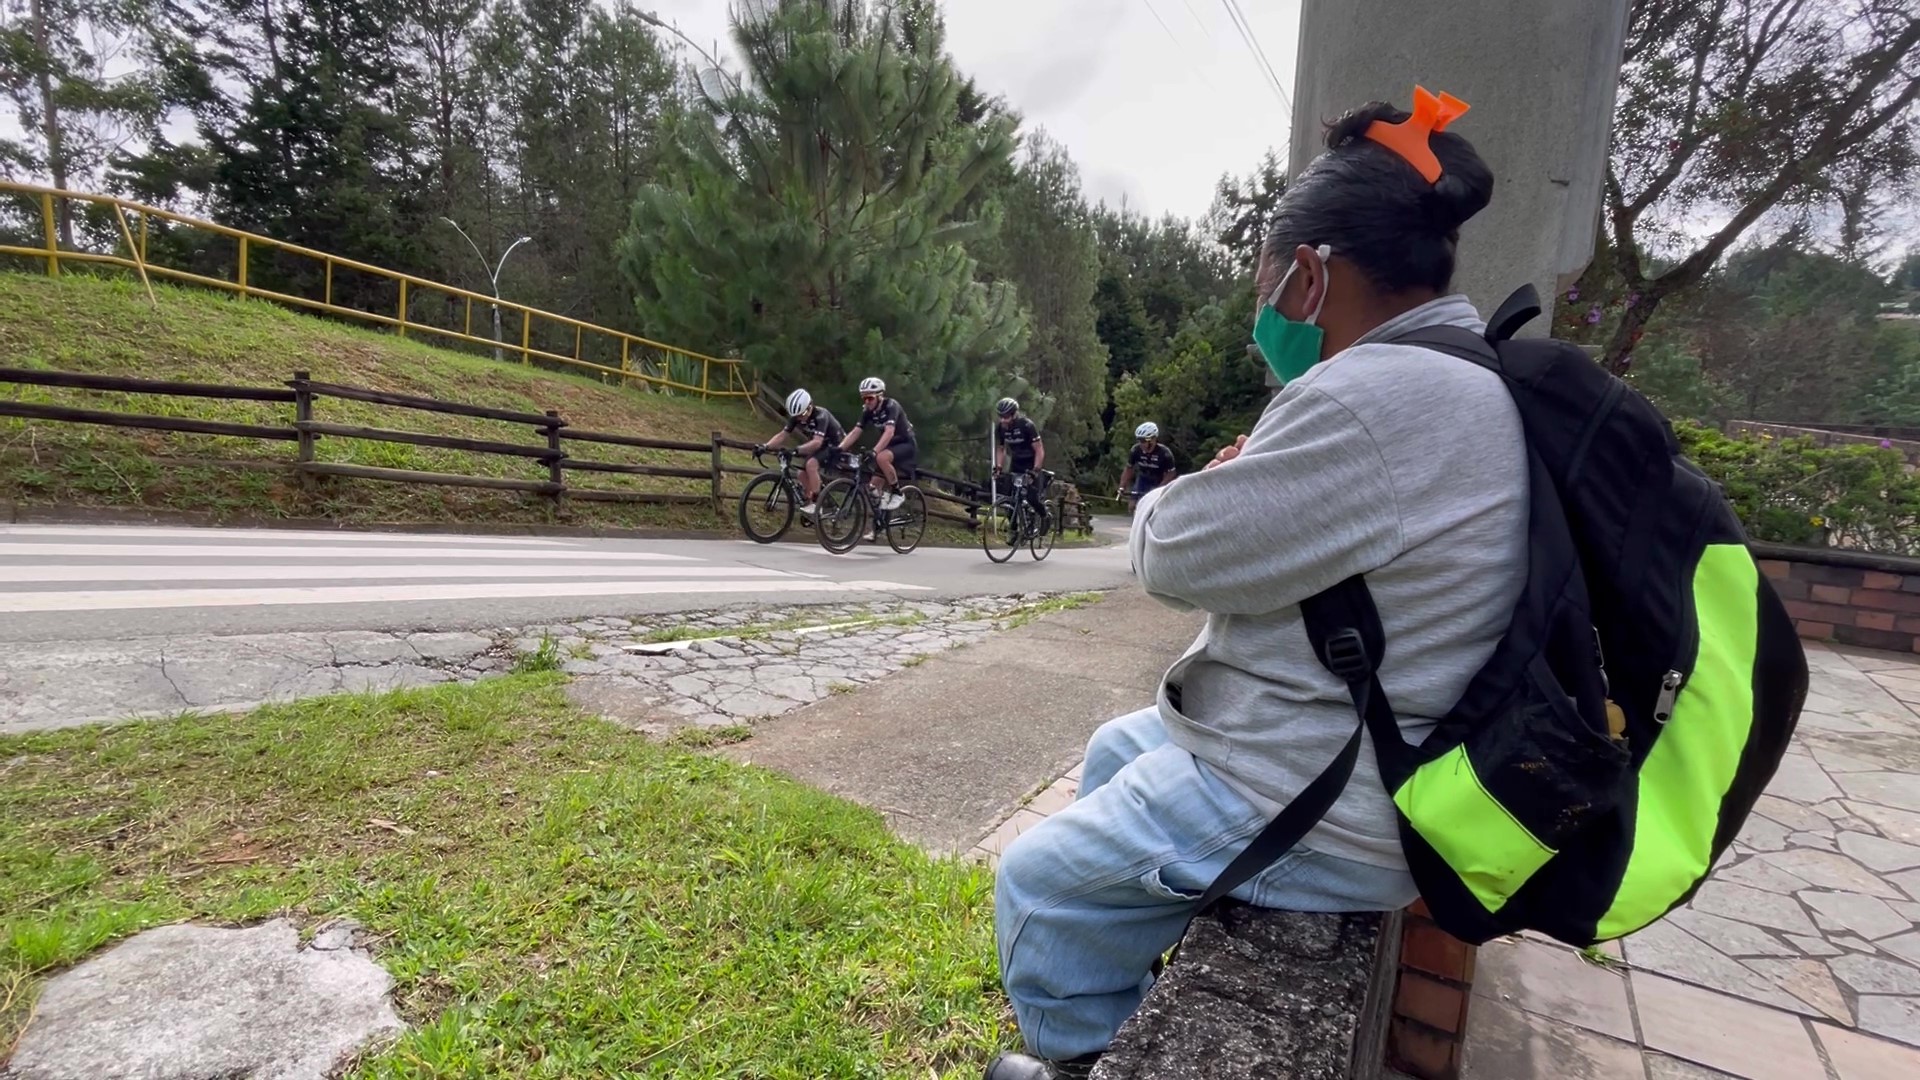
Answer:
[{"left": 1200, "top": 575, "right": 1405, "bottom": 911}]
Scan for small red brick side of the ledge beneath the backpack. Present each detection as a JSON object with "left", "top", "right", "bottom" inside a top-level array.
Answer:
[{"left": 1386, "top": 901, "right": 1475, "bottom": 1080}]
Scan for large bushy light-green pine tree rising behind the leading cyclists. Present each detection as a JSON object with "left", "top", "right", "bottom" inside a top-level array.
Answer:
[{"left": 624, "top": 0, "right": 1025, "bottom": 461}]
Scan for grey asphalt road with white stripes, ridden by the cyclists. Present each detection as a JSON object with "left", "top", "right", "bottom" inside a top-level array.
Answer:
[{"left": 0, "top": 525, "right": 1129, "bottom": 642}]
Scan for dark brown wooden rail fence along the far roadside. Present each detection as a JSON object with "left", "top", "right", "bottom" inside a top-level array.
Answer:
[{"left": 0, "top": 367, "right": 1092, "bottom": 532}]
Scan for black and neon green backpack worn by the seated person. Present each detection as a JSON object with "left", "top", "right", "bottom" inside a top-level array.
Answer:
[{"left": 1202, "top": 288, "right": 1807, "bottom": 945}]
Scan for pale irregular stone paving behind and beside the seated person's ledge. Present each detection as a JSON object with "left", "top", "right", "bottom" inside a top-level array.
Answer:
[{"left": 973, "top": 642, "right": 1920, "bottom": 1080}]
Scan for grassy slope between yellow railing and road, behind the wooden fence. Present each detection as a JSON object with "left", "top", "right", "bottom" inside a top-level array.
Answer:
[{"left": 0, "top": 273, "right": 774, "bottom": 527}]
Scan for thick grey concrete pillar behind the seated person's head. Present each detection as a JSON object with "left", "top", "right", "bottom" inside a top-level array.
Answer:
[{"left": 1290, "top": 0, "right": 1628, "bottom": 334}]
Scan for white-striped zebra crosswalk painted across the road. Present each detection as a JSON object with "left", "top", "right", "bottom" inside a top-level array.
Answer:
[{"left": 0, "top": 525, "right": 922, "bottom": 613}]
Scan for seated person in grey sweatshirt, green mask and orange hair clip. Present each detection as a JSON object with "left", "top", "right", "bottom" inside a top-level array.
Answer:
[{"left": 987, "top": 92, "right": 1528, "bottom": 1080}]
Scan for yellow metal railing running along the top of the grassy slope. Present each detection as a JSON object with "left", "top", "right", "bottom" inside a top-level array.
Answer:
[{"left": 0, "top": 181, "right": 756, "bottom": 398}]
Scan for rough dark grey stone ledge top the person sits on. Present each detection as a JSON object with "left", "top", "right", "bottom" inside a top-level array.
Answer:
[{"left": 1094, "top": 901, "right": 1402, "bottom": 1080}]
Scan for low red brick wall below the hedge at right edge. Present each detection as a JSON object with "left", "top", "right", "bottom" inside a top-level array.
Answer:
[{"left": 1753, "top": 544, "right": 1920, "bottom": 653}]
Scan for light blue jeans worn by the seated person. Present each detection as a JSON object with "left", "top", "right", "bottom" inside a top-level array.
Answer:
[{"left": 993, "top": 709, "right": 1417, "bottom": 1061}]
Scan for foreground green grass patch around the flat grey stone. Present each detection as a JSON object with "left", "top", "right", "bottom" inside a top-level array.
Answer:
[{"left": 0, "top": 675, "right": 1012, "bottom": 1080}]
